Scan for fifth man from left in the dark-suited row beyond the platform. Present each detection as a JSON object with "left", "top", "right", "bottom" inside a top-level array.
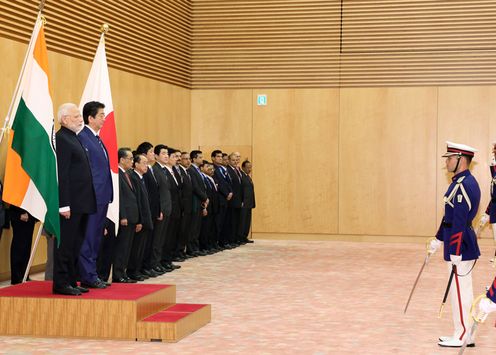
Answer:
[{"left": 161, "top": 147, "right": 182, "bottom": 270}]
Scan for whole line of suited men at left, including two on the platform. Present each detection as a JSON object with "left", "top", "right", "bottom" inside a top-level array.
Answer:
[{"left": 5, "top": 101, "right": 255, "bottom": 295}]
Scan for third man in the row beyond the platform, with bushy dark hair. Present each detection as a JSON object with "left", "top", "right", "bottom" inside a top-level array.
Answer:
[{"left": 136, "top": 142, "right": 164, "bottom": 277}]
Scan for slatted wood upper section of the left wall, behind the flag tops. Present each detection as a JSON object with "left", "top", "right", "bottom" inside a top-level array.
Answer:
[{"left": 0, "top": 0, "right": 191, "bottom": 87}]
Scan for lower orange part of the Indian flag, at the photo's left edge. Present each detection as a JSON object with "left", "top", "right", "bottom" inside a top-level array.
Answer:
[{"left": 3, "top": 130, "right": 31, "bottom": 207}]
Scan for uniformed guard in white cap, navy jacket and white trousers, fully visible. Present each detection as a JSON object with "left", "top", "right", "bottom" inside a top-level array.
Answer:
[{"left": 429, "top": 142, "right": 480, "bottom": 347}]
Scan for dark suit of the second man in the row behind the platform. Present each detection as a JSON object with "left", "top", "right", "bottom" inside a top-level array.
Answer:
[{"left": 127, "top": 170, "right": 153, "bottom": 278}]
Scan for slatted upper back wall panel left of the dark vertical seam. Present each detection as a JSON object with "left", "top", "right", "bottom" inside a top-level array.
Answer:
[{"left": 192, "top": 0, "right": 340, "bottom": 88}]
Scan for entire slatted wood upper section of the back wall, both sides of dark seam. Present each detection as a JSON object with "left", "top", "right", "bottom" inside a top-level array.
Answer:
[{"left": 192, "top": 0, "right": 496, "bottom": 88}]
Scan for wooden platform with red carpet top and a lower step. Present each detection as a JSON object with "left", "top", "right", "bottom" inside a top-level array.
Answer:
[{"left": 0, "top": 281, "right": 211, "bottom": 342}]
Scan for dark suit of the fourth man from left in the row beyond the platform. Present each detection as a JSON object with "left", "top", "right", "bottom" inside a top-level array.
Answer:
[{"left": 150, "top": 163, "right": 172, "bottom": 268}]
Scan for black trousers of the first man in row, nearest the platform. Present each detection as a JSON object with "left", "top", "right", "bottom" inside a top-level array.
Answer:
[{"left": 112, "top": 223, "right": 136, "bottom": 280}]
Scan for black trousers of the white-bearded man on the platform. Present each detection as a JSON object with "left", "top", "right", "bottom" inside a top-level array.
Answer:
[{"left": 53, "top": 212, "right": 88, "bottom": 288}]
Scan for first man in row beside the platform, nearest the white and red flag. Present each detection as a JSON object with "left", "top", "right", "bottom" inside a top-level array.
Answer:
[{"left": 112, "top": 148, "right": 139, "bottom": 283}]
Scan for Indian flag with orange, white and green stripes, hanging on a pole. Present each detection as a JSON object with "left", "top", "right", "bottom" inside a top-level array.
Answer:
[{"left": 3, "top": 15, "right": 60, "bottom": 240}]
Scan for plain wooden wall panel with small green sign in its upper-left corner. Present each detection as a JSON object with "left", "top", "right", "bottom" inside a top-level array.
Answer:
[{"left": 252, "top": 89, "right": 339, "bottom": 233}]
